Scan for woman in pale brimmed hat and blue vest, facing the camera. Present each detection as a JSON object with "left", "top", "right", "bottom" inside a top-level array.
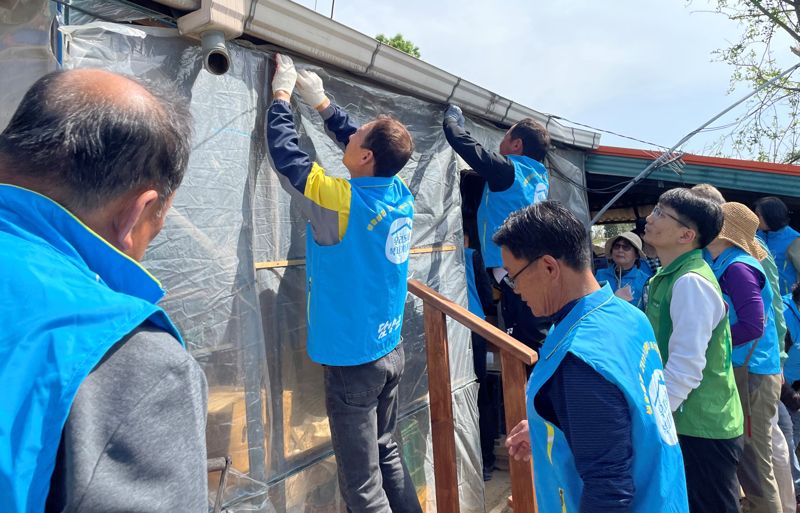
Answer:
[{"left": 595, "top": 232, "right": 650, "bottom": 310}]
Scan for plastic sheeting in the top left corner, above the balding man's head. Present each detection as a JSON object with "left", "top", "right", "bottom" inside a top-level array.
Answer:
[{"left": 0, "top": 0, "right": 56, "bottom": 130}]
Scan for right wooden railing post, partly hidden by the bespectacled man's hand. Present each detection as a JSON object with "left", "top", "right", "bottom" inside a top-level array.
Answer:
[{"left": 500, "top": 351, "right": 538, "bottom": 513}]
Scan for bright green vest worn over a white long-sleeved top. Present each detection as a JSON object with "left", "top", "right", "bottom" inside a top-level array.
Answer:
[{"left": 646, "top": 249, "right": 744, "bottom": 440}]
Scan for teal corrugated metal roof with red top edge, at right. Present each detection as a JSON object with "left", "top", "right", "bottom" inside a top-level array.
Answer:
[{"left": 586, "top": 146, "right": 800, "bottom": 198}]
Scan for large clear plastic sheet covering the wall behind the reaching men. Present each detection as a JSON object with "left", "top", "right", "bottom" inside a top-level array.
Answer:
[{"left": 0, "top": 12, "right": 585, "bottom": 513}]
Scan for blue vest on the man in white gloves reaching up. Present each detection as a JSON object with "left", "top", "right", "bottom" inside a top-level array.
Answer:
[{"left": 306, "top": 176, "right": 414, "bottom": 366}]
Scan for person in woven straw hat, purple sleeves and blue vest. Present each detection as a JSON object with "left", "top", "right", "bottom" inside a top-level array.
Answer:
[{"left": 707, "top": 202, "right": 781, "bottom": 511}]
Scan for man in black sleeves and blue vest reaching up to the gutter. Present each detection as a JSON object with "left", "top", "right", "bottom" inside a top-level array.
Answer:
[{"left": 443, "top": 105, "right": 550, "bottom": 349}]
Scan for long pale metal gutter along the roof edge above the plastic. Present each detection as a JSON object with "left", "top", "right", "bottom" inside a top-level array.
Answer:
[{"left": 159, "top": 0, "right": 600, "bottom": 149}]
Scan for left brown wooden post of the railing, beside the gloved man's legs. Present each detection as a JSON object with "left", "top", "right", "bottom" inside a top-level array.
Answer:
[{"left": 423, "top": 303, "right": 459, "bottom": 513}]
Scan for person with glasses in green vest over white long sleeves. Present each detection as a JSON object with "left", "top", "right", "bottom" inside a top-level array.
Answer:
[{"left": 645, "top": 188, "right": 744, "bottom": 513}]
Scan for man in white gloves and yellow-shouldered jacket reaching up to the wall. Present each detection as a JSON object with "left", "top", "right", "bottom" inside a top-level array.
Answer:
[{"left": 267, "top": 55, "right": 421, "bottom": 513}]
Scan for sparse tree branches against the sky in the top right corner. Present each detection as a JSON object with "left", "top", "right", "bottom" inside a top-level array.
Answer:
[{"left": 704, "top": 0, "right": 800, "bottom": 163}]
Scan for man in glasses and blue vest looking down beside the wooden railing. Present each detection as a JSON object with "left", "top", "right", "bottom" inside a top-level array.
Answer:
[{"left": 494, "top": 201, "right": 689, "bottom": 513}]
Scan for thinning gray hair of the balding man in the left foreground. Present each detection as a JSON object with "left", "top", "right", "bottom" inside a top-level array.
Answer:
[{"left": 0, "top": 71, "right": 192, "bottom": 212}]
